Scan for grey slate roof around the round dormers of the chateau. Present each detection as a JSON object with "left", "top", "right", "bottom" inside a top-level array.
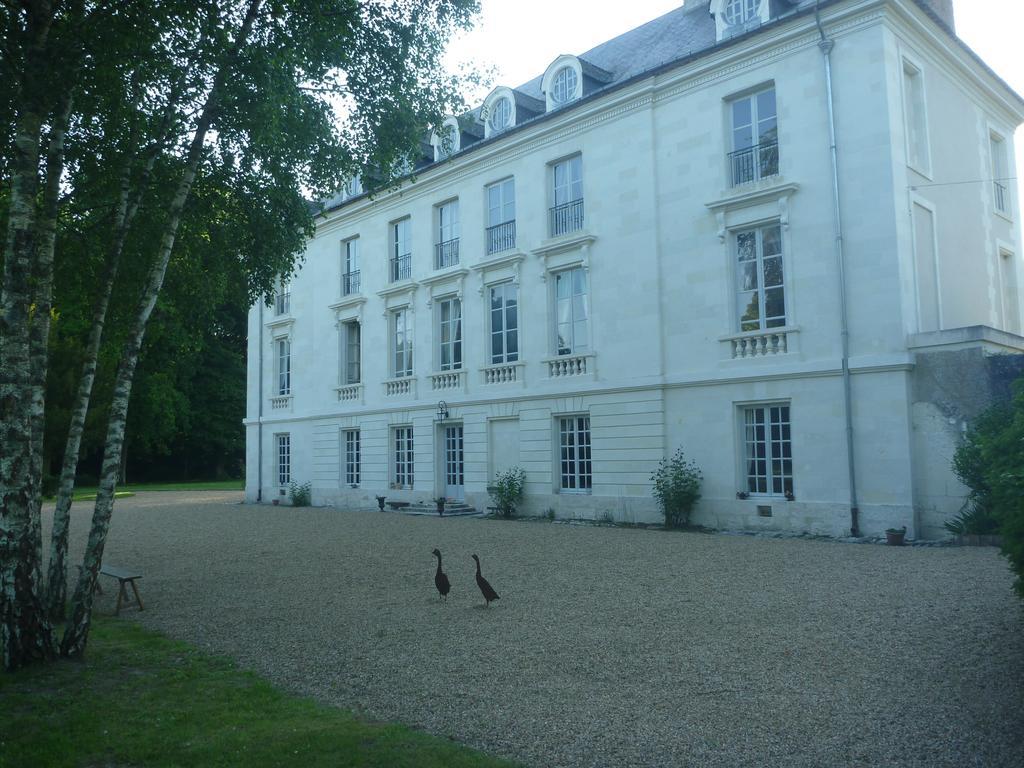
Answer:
[{"left": 322, "top": 0, "right": 1019, "bottom": 213}]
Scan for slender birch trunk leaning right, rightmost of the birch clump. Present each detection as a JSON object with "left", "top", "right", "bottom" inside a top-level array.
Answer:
[{"left": 60, "top": 0, "right": 263, "bottom": 656}]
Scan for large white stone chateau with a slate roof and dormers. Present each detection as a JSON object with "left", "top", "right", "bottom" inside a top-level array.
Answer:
[{"left": 246, "top": 0, "right": 1024, "bottom": 538}]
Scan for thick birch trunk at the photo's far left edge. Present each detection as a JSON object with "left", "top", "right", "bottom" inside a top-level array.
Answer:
[{"left": 0, "top": 4, "right": 53, "bottom": 670}]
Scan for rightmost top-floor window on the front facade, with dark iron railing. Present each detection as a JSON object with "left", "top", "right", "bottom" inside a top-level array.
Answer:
[{"left": 729, "top": 88, "right": 778, "bottom": 185}]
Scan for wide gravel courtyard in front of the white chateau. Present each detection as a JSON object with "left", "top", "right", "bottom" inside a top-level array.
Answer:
[{"left": 54, "top": 492, "right": 1024, "bottom": 768}]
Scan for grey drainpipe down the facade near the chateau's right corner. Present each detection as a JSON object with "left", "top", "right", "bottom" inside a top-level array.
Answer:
[{"left": 814, "top": 0, "right": 860, "bottom": 537}]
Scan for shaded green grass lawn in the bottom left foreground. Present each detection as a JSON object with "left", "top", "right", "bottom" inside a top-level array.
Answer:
[{"left": 0, "top": 618, "right": 520, "bottom": 768}]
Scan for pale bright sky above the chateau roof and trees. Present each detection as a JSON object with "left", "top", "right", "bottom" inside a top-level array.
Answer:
[{"left": 447, "top": 0, "right": 1024, "bottom": 217}]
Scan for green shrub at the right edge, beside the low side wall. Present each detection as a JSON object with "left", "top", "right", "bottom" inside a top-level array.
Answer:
[{"left": 946, "top": 378, "right": 1024, "bottom": 597}]
